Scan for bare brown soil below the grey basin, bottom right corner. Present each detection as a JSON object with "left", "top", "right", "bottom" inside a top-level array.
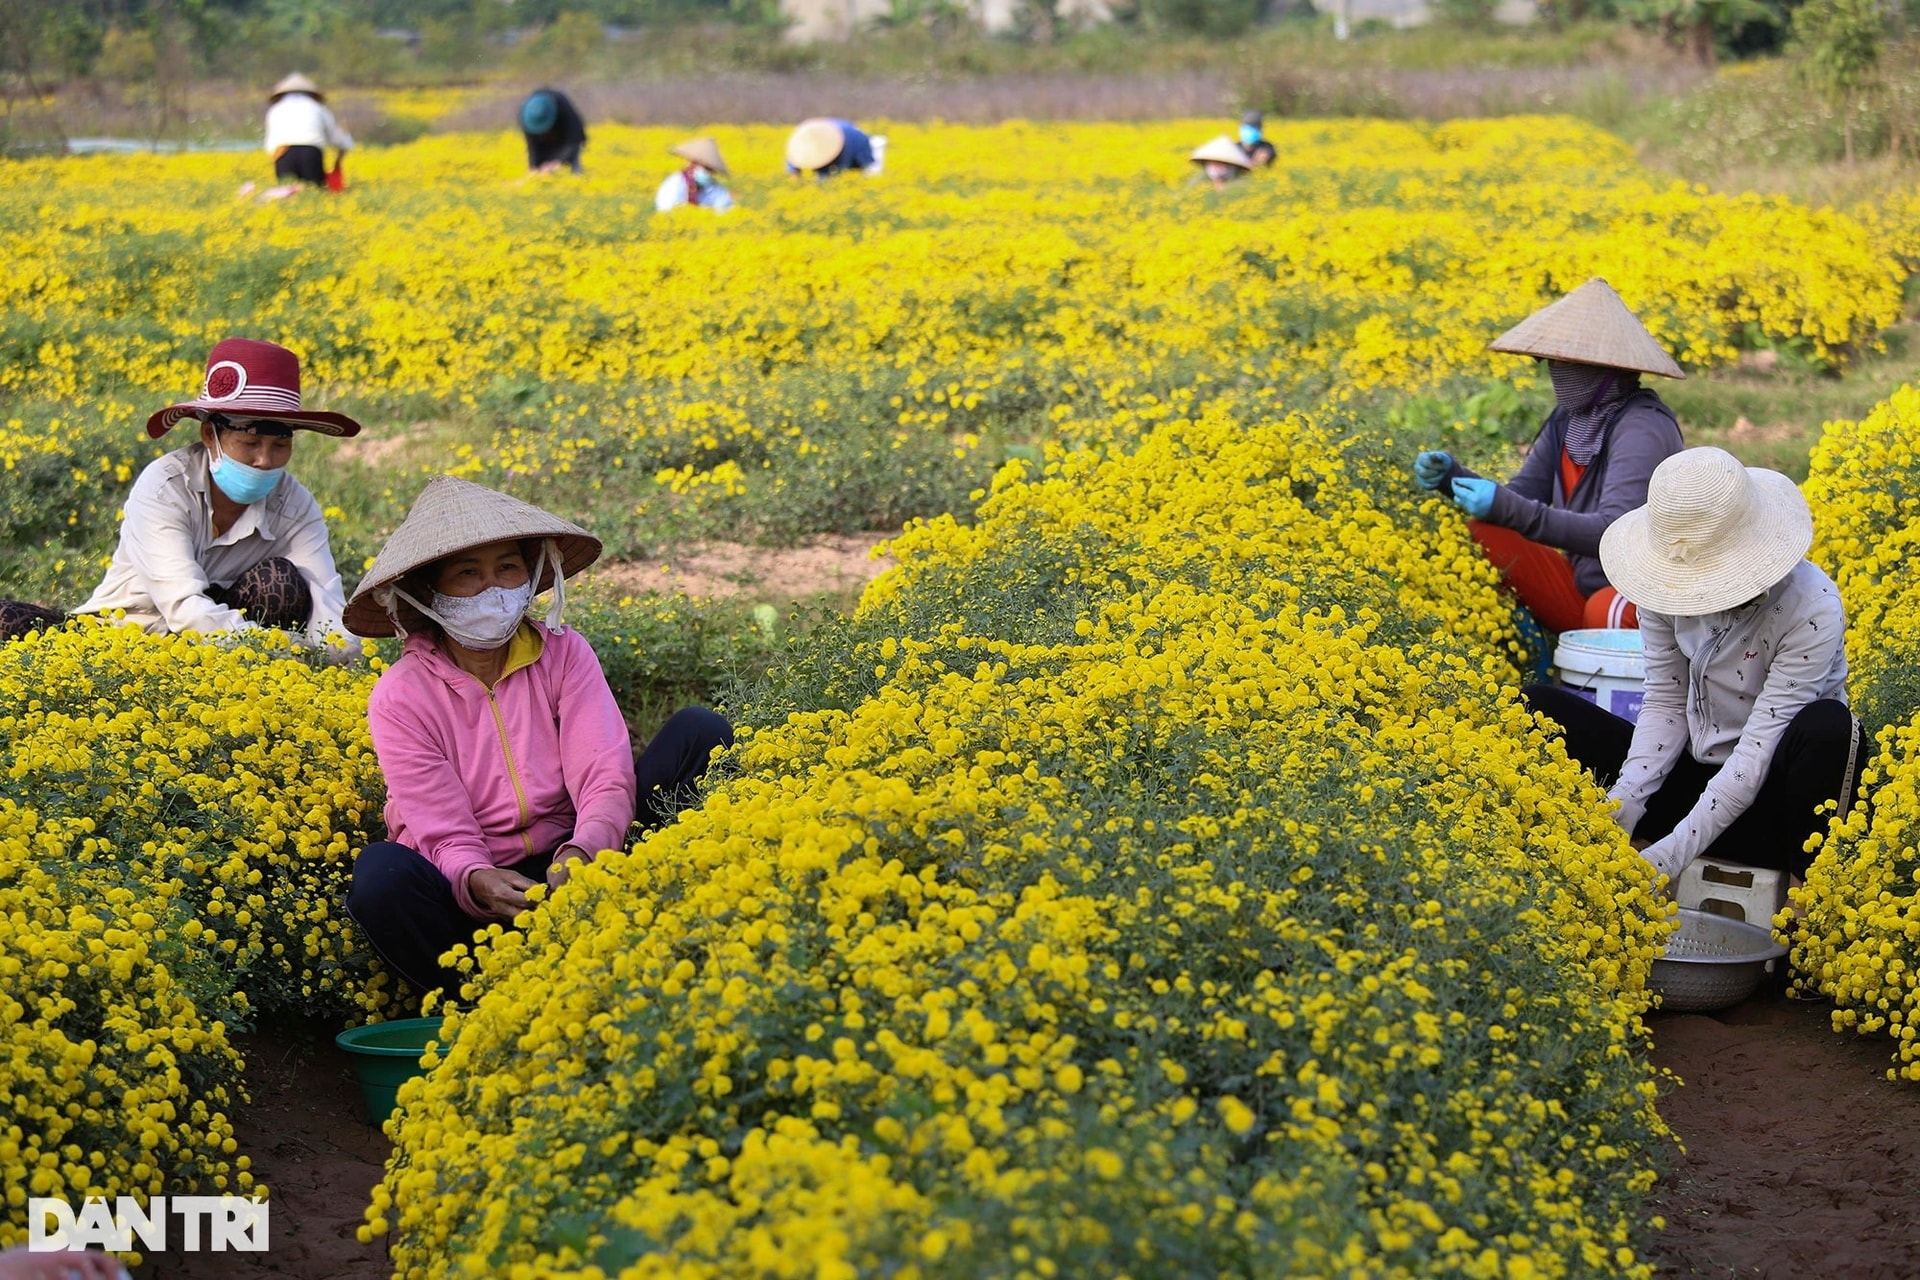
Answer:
[{"left": 1653, "top": 1000, "right": 1920, "bottom": 1280}]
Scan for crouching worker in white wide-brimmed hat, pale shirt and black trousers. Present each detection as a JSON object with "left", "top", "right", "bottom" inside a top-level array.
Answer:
[{"left": 1526, "top": 449, "right": 1866, "bottom": 879}]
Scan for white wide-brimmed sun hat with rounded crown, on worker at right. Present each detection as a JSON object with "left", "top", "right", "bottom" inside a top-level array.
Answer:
[{"left": 1599, "top": 447, "right": 1812, "bottom": 618}]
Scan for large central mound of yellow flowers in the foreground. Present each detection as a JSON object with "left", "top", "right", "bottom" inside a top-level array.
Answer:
[{"left": 367, "top": 395, "right": 1667, "bottom": 1276}]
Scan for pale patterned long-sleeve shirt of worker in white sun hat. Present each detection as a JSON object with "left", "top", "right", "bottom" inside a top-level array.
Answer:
[{"left": 1611, "top": 560, "right": 1847, "bottom": 877}]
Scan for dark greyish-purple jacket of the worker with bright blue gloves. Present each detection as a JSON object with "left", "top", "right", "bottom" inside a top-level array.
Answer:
[{"left": 1442, "top": 388, "right": 1686, "bottom": 595}]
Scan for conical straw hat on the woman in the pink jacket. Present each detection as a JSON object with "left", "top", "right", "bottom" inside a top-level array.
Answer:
[{"left": 346, "top": 476, "right": 601, "bottom": 635}]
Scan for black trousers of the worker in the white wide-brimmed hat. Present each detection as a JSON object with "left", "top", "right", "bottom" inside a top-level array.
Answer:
[{"left": 1521, "top": 685, "right": 1870, "bottom": 877}]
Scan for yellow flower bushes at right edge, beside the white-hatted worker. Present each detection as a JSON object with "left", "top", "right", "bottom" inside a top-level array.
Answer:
[{"left": 1793, "top": 386, "right": 1920, "bottom": 1080}]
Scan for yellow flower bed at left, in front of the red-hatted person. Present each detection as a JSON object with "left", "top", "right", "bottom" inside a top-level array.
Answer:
[{"left": 0, "top": 622, "right": 394, "bottom": 1247}]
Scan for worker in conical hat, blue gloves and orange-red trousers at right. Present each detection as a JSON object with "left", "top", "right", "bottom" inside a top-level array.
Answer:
[{"left": 1413, "top": 278, "right": 1686, "bottom": 631}]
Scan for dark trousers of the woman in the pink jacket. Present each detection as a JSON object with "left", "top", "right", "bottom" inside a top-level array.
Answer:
[{"left": 348, "top": 706, "right": 733, "bottom": 994}]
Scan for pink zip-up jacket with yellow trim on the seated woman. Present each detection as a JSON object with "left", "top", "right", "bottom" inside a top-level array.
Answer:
[{"left": 367, "top": 622, "right": 634, "bottom": 917}]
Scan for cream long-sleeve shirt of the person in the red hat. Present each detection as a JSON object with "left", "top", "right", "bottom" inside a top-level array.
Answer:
[{"left": 73, "top": 441, "right": 359, "bottom": 651}]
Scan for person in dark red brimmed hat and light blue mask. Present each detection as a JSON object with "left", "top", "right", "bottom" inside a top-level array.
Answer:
[{"left": 0, "top": 338, "right": 361, "bottom": 652}]
